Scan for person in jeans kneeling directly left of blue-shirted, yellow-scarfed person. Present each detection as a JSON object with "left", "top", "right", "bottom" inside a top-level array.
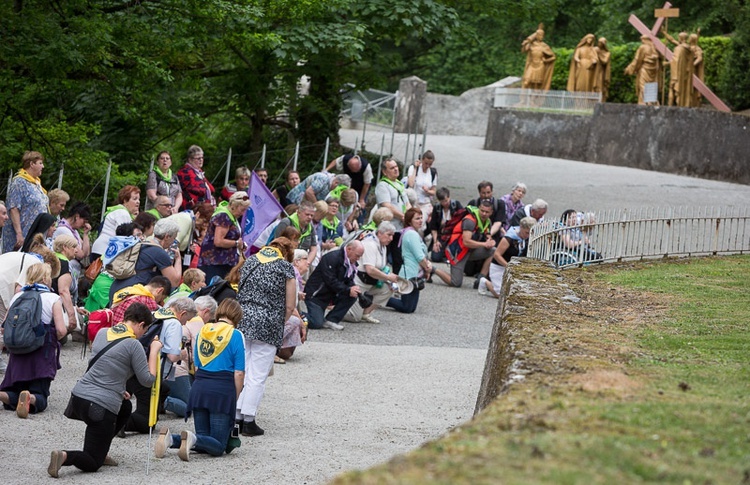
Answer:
[{"left": 164, "top": 296, "right": 218, "bottom": 418}]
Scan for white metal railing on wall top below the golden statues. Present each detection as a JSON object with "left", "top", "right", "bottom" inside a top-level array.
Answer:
[{"left": 494, "top": 88, "right": 601, "bottom": 114}]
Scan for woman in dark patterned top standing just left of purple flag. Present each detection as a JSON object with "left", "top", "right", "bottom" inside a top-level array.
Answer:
[{"left": 198, "top": 190, "right": 250, "bottom": 284}]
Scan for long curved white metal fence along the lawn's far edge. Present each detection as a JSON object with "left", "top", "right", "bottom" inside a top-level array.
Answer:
[{"left": 527, "top": 207, "right": 750, "bottom": 268}]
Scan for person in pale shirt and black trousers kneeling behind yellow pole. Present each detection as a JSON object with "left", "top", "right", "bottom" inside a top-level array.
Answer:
[{"left": 123, "top": 298, "right": 198, "bottom": 436}]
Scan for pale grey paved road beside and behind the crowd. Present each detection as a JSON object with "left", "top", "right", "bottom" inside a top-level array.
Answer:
[{"left": 0, "top": 131, "right": 750, "bottom": 484}]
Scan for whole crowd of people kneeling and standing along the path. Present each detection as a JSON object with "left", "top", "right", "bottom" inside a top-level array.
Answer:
[{"left": 0, "top": 146, "right": 604, "bottom": 477}]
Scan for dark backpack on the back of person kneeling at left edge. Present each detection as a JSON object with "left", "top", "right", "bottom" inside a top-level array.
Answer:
[{"left": 3, "top": 288, "right": 47, "bottom": 354}]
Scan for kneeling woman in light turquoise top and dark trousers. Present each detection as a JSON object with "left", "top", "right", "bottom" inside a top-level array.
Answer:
[{"left": 386, "top": 207, "right": 450, "bottom": 313}]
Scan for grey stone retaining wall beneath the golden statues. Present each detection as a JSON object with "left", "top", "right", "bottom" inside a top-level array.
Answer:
[{"left": 484, "top": 103, "right": 750, "bottom": 184}]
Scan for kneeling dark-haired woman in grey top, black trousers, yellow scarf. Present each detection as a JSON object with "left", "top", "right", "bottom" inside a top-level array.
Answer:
[{"left": 47, "top": 304, "right": 162, "bottom": 478}]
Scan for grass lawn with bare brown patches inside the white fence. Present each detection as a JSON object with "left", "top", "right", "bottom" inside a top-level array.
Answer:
[{"left": 335, "top": 256, "right": 750, "bottom": 484}]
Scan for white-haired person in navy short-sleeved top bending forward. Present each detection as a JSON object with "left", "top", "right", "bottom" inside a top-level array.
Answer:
[{"left": 109, "top": 218, "right": 182, "bottom": 301}]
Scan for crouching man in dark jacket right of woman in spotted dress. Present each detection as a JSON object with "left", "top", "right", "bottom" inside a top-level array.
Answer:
[{"left": 305, "top": 241, "right": 365, "bottom": 330}]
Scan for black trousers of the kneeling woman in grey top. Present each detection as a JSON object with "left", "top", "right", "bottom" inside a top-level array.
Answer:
[{"left": 63, "top": 396, "right": 133, "bottom": 472}]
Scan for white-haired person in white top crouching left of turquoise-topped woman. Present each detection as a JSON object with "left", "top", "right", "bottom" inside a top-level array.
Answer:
[{"left": 344, "top": 221, "right": 398, "bottom": 323}]
